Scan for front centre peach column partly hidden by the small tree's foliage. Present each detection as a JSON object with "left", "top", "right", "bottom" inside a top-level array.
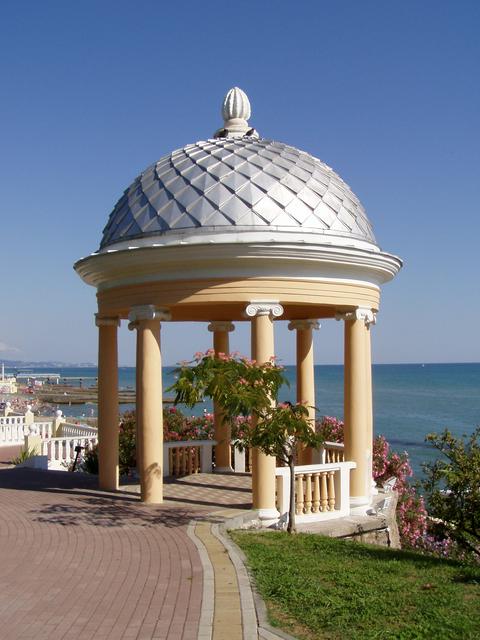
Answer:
[{"left": 245, "top": 300, "right": 283, "bottom": 526}]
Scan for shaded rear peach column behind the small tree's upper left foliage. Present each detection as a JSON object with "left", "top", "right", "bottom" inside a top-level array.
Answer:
[{"left": 208, "top": 321, "right": 235, "bottom": 473}]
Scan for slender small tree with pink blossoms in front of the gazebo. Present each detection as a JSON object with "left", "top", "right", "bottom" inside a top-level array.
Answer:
[{"left": 169, "top": 350, "right": 324, "bottom": 533}]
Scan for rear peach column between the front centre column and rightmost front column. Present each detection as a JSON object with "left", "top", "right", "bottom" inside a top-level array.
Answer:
[{"left": 288, "top": 320, "right": 320, "bottom": 464}]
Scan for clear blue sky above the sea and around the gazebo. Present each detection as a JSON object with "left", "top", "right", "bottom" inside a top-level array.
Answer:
[{"left": 0, "top": 0, "right": 480, "bottom": 364}]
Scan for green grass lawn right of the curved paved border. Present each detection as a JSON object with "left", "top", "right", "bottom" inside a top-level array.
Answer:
[{"left": 231, "top": 531, "right": 480, "bottom": 640}]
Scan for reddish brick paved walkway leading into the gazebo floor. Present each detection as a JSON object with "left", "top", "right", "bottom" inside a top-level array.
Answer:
[{"left": 0, "top": 468, "right": 255, "bottom": 640}]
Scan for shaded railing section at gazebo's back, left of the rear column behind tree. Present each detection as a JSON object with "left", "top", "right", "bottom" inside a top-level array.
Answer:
[{"left": 163, "top": 440, "right": 217, "bottom": 477}]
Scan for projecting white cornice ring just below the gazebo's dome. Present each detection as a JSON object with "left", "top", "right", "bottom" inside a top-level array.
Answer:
[{"left": 74, "top": 242, "right": 402, "bottom": 290}]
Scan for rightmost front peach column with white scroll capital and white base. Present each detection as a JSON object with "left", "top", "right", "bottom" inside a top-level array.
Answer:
[{"left": 343, "top": 308, "right": 374, "bottom": 513}]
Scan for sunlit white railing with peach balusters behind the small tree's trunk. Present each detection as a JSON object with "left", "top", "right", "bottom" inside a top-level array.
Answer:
[{"left": 275, "top": 462, "right": 356, "bottom": 522}]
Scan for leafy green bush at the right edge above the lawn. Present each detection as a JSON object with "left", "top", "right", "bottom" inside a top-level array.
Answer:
[{"left": 422, "top": 427, "right": 480, "bottom": 556}]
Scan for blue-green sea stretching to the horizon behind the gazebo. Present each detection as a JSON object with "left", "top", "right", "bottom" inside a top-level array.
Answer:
[{"left": 6, "top": 363, "right": 480, "bottom": 476}]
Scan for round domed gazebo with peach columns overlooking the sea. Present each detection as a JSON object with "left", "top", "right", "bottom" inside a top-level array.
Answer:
[{"left": 75, "top": 87, "right": 402, "bottom": 522}]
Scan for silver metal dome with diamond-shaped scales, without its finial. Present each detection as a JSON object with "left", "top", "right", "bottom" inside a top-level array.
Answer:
[{"left": 100, "top": 136, "right": 378, "bottom": 250}]
